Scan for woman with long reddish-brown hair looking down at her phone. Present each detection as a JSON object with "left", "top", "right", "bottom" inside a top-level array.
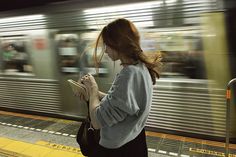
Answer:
[{"left": 81, "top": 19, "right": 160, "bottom": 157}]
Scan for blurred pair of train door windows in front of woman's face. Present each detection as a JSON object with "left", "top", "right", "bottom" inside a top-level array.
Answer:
[{"left": 55, "top": 32, "right": 107, "bottom": 76}]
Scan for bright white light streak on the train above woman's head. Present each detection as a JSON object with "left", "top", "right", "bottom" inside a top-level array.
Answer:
[{"left": 83, "top": 0, "right": 163, "bottom": 29}]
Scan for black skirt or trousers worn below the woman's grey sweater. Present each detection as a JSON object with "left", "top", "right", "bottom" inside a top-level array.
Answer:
[{"left": 89, "top": 129, "right": 148, "bottom": 157}]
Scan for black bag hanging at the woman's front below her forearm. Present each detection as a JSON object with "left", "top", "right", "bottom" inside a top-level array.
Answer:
[{"left": 76, "top": 116, "right": 100, "bottom": 156}]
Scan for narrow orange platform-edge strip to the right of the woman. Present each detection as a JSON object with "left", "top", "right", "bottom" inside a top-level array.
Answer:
[{"left": 146, "top": 131, "right": 236, "bottom": 149}]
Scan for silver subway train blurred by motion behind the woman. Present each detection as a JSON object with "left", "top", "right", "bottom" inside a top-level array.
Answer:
[{"left": 0, "top": 0, "right": 236, "bottom": 140}]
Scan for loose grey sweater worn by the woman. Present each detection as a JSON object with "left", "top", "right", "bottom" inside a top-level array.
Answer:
[{"left": 96, "top": 63, "right": 153, "bottom": 148}]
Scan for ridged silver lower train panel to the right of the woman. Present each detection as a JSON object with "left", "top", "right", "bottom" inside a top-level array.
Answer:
[{"left": 147, "top": 79, "right": 226, "bottom": 137}]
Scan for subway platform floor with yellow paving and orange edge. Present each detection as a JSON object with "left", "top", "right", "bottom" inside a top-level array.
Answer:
[{"left": 0, "top": 111, "right": 236, "bottom": 157}]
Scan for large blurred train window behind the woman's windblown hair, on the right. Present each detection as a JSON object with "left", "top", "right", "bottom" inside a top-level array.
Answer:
[{"left": 141, "top": 28, "right": 206, "bottom": 79}]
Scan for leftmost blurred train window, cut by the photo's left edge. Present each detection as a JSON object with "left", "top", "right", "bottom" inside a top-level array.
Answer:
[{"left": 1, "top": 36, "right": 33, "bottom": 75}]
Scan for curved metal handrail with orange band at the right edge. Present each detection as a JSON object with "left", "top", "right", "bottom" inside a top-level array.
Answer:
[{"left": 225, "top": 78, "right": 236, "bottom": 157}]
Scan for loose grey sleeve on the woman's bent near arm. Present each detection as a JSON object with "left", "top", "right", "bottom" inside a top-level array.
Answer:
[{"left": 96, "top": 69, "right": 140, "bottom": 127}]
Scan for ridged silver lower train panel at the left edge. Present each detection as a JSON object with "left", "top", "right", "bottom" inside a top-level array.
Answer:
[{"left": 0, "top": 77, "right": 62, "bottom": 114}]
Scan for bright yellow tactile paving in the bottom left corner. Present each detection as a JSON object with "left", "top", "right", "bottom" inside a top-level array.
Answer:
[{"left": 0, "top": 137, "right": 84, "bottom": 157}]
